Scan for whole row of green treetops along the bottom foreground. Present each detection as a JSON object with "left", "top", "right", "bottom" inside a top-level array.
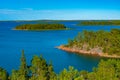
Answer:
[{"left": 0, "top": 51, "right": 120, "bottom": 80}]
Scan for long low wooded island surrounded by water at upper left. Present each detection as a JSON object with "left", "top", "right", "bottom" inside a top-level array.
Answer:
[{"left": 14, "top": 24, "right": 67, "bottom": 30}]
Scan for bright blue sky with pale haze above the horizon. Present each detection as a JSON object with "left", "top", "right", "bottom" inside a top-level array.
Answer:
[{"left": 0, "top": 0, "right": 120, "bottom": 20}]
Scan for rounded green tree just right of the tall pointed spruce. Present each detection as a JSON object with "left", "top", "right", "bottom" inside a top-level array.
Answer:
[{"left": 30, "top": 56, "right": 47, "bottom": 80}]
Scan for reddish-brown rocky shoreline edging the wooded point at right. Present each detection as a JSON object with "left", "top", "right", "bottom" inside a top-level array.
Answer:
[{"left": 57, "top": 45, "right": 120, "bottom": 58}]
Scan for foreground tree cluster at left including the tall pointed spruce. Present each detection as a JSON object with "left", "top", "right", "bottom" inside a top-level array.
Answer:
[{"left": 10, "top": 50, "right": 57, "bottom": 80}]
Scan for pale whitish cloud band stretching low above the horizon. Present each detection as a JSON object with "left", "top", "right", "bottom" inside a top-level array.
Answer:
[{"left": 0, "top": 8, "right": 120, "bottom": 20}]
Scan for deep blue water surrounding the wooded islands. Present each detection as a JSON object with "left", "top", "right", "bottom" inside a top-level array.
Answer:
[{"left": 0, "top": 21, "right": 120, "bottom": 73}]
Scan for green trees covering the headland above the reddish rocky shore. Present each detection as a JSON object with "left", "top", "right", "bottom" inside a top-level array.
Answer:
[{"left": 67, "top": 29, "right": 120, "bottom": 55}]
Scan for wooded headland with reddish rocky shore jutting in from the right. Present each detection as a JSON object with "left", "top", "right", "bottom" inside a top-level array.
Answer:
[{"left": 58, "top": 29, "right": 120, "bottom": 58}]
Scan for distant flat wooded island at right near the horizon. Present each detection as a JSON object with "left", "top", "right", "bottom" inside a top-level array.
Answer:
[{"left": 77, "top": 20, "right": 120, "bottom": 26}]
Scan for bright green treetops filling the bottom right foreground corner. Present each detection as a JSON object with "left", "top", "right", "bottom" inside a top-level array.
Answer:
[{"left": 58, "top": 59, "right": 120, "bottom": 80}]
